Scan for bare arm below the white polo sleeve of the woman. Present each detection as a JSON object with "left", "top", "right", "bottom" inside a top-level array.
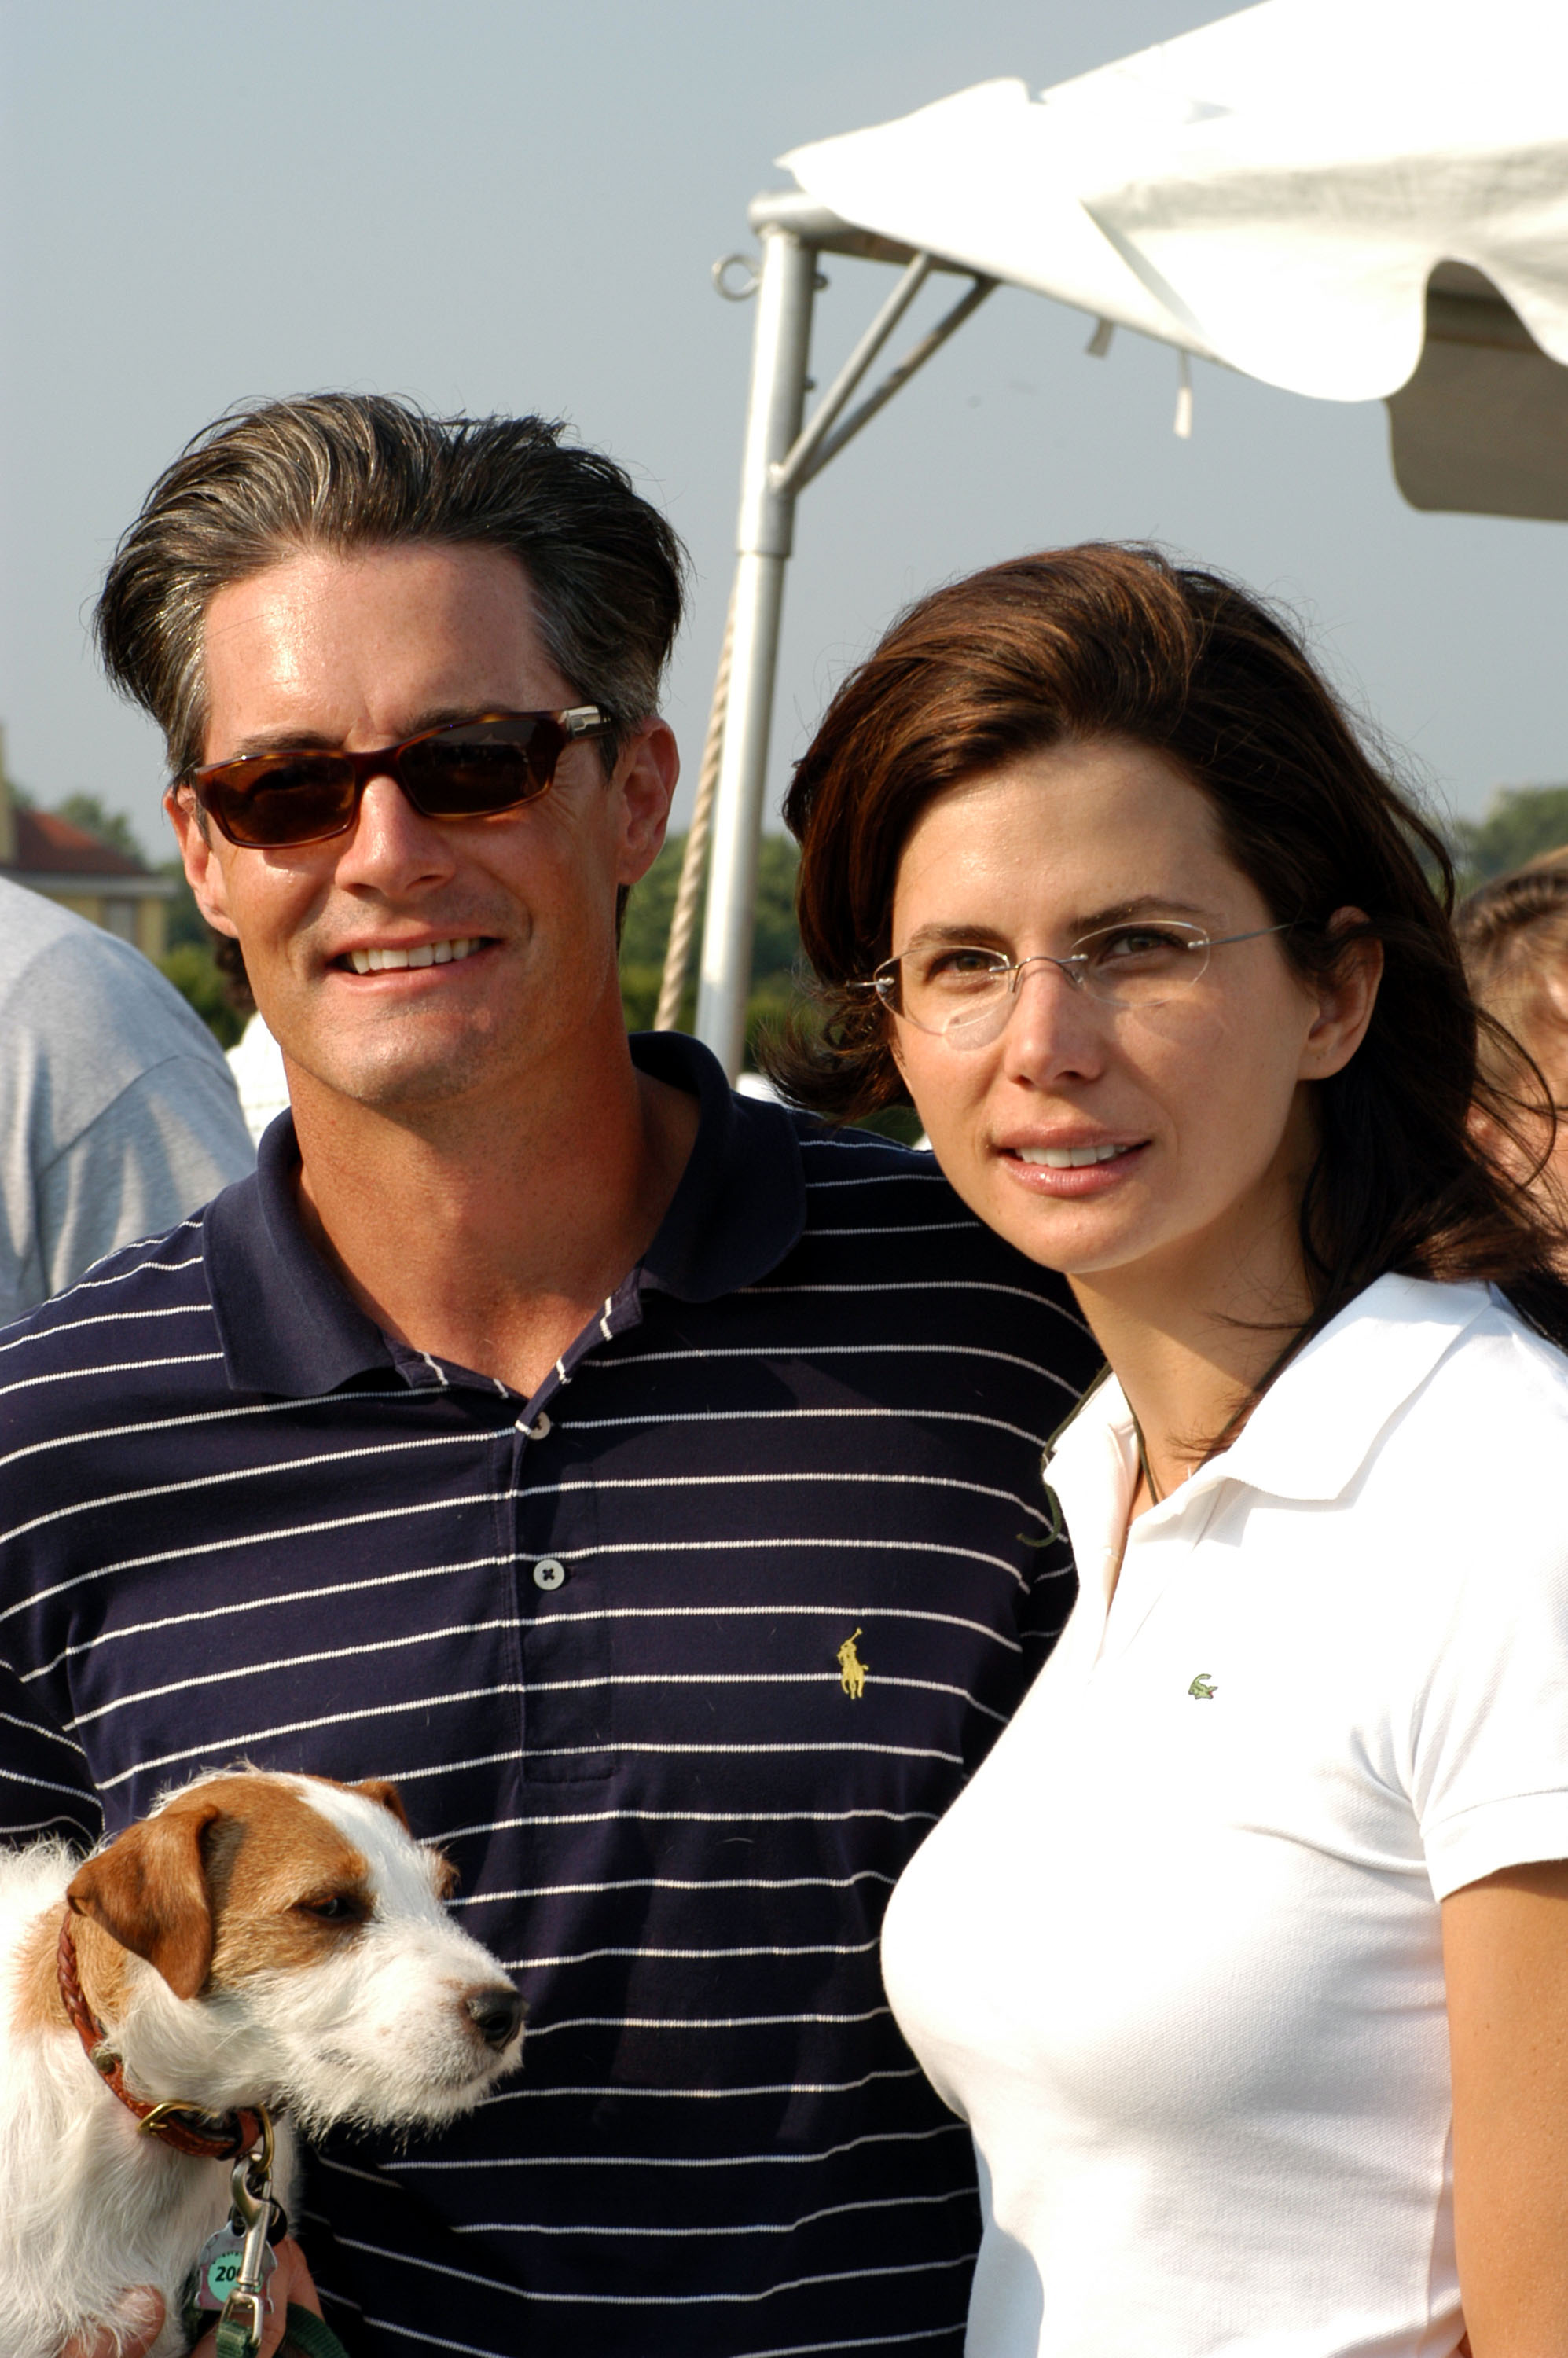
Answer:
[{"left": 1443, "top": 1860, "right": 1568, "bottom": 2358}]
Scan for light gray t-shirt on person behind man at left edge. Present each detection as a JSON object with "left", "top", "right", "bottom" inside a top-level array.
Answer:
[{"left": 0, "top": 877, "right": 255, "bottom": 1325}]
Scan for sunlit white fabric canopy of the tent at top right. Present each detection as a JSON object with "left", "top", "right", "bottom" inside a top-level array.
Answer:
[{"left": 780, "top": 0, "right": 1568, "bottom": 406}]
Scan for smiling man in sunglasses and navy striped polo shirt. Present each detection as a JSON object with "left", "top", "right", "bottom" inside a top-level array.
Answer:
[{"left": 0, "top": 396, "right": 1094, "bottom": 2358}]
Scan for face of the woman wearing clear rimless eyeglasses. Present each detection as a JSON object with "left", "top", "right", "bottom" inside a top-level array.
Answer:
[{"left": 889, "top": 740, "right": 1375, "bottom": 1283}]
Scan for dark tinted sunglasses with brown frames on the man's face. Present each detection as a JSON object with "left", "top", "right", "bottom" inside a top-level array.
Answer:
[{"left": 179, "top": 705, "right": 608, "bottom": 851}]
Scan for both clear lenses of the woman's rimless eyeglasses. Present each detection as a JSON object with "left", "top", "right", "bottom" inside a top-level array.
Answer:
[{"left": 879, "top": 920, "right": 1210, "bottom": 1033}]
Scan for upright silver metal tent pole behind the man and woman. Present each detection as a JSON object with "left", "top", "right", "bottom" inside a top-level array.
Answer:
[{"left": 698, "top": 224, "right": 816, "bottom": 1080}]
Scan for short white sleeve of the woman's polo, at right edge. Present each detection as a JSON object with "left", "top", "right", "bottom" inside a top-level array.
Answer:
[{"left": 1412, "top": 1471, "right": 1568, "bottom": 1898}]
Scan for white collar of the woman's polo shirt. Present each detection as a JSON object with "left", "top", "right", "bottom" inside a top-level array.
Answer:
[{"left": 1045, "top": 1276, "right": 1490, "bottom": 1554}]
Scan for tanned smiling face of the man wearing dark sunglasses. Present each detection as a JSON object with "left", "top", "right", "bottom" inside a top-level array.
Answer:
[{"left": 172, "top": 547, "right": 677, "bottom": 1115}]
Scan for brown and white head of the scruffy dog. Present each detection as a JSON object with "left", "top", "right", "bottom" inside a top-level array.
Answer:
[{"left": 66, "top": 1771, "right": 523, "bottom": 2132}]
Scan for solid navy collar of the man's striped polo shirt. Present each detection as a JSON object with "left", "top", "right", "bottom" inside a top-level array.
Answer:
[{"left": 203, "top": 1033, "right": 806, "bottom": 1398}]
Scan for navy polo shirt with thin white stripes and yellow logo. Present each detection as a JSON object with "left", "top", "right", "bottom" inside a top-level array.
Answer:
[{"left": 0, "top": 1035, "right": 1099, "bottom": 2358}]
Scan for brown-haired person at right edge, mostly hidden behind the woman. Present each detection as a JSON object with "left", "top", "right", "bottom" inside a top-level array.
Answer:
[{"left": 1455, "top": 851, "right": 1568, "bottom": 1269}]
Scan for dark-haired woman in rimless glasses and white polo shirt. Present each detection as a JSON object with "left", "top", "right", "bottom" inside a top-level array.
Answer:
[{"left": 776, "top": 547, "right": 1568, "bottom": 2358}]
